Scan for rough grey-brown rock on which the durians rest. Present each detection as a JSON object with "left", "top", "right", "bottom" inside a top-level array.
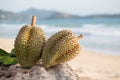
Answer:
[{"left": 0, "top": 63, "right": 80, "bottom": 80}]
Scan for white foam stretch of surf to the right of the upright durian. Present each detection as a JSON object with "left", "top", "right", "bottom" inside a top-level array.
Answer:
[{"left": 40, "top": 24, "right": 120, "bottom": 37}]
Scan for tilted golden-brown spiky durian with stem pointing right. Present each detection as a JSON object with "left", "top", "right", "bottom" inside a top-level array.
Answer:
[{"left": 42, "top": 30, "right": 82, "bottom": 68}]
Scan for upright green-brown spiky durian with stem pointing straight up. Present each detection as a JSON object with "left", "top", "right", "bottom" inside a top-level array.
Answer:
[{"left": 14, "top": 16, "right": 45, "bottom": 68}]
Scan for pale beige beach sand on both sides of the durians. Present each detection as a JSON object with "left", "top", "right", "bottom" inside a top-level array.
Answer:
[{"left": 0, "top": 38, "right": 120, "bottom": 80}]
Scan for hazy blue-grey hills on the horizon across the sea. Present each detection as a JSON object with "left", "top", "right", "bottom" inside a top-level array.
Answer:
[{"left": 0, "top": 8, "right": 120, "bottom": 21}]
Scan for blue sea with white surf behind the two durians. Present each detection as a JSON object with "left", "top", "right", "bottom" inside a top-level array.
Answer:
[{"left": 0, "top": 18, "right": 120, "bottom": 55}]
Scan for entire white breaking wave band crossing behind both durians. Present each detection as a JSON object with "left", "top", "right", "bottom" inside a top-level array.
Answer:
[{"left": 0, "top": 24, "right": 120, "bottom": 37}]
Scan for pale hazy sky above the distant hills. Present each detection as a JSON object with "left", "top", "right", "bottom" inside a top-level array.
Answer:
[{"left": 0, "top": 0, "right": 120, "bottom": 15}]
